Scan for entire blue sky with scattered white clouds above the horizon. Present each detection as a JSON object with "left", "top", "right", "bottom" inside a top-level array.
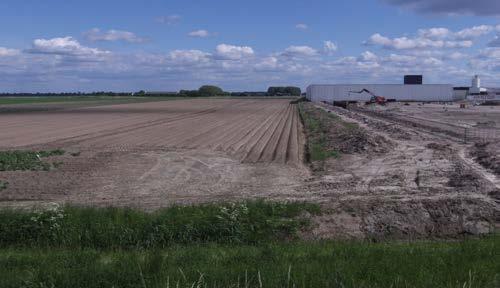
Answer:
[{"left": 0, "top": 0, "right": 500, "bottom": 92}]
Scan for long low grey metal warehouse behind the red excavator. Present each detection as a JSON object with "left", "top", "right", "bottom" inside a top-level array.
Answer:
[{"left": 307, "top": 84, "right": 453, "bottom": 102}]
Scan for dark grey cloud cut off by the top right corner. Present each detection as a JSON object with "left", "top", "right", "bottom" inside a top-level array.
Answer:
[{"left": 383, "top": 0, "right": 500, "bottom": 16}]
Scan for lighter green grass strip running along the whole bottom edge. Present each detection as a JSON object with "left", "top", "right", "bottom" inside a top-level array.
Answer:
[{"left": 0, "top": 236, "right": 500, "bottom": 288}]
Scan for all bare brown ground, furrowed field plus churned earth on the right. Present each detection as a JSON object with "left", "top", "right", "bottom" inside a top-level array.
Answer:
[{"left": 0, "top": 99, "right": 500, "bottom": 239}]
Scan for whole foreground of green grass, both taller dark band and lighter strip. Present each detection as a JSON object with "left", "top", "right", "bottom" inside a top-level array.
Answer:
[{"left": 0, "top": 201, "right": 500, "bottom": 288}]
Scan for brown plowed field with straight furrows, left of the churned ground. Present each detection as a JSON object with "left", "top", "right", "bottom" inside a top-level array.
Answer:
[{"left": 0, "top": 99, "right": 308, "bottom": 208}]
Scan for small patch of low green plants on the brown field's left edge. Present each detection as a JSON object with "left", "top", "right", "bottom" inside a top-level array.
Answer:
[{"left": 0, "top": 149, "right": 65, "bottom": 171}]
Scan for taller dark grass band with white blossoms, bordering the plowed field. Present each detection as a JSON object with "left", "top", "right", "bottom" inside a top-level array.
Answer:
[{"left": 0, "top": 201, "right": 320, "bottom": 249}]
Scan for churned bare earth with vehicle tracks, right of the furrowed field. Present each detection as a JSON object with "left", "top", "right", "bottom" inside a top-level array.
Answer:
[{"left": 304, "top": 104, "right": 500, "bottom": 239}]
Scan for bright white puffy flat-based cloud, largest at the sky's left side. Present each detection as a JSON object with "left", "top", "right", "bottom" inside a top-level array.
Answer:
[{"left": 27, "top": 36, "right": 111, "bottom": 56}]
